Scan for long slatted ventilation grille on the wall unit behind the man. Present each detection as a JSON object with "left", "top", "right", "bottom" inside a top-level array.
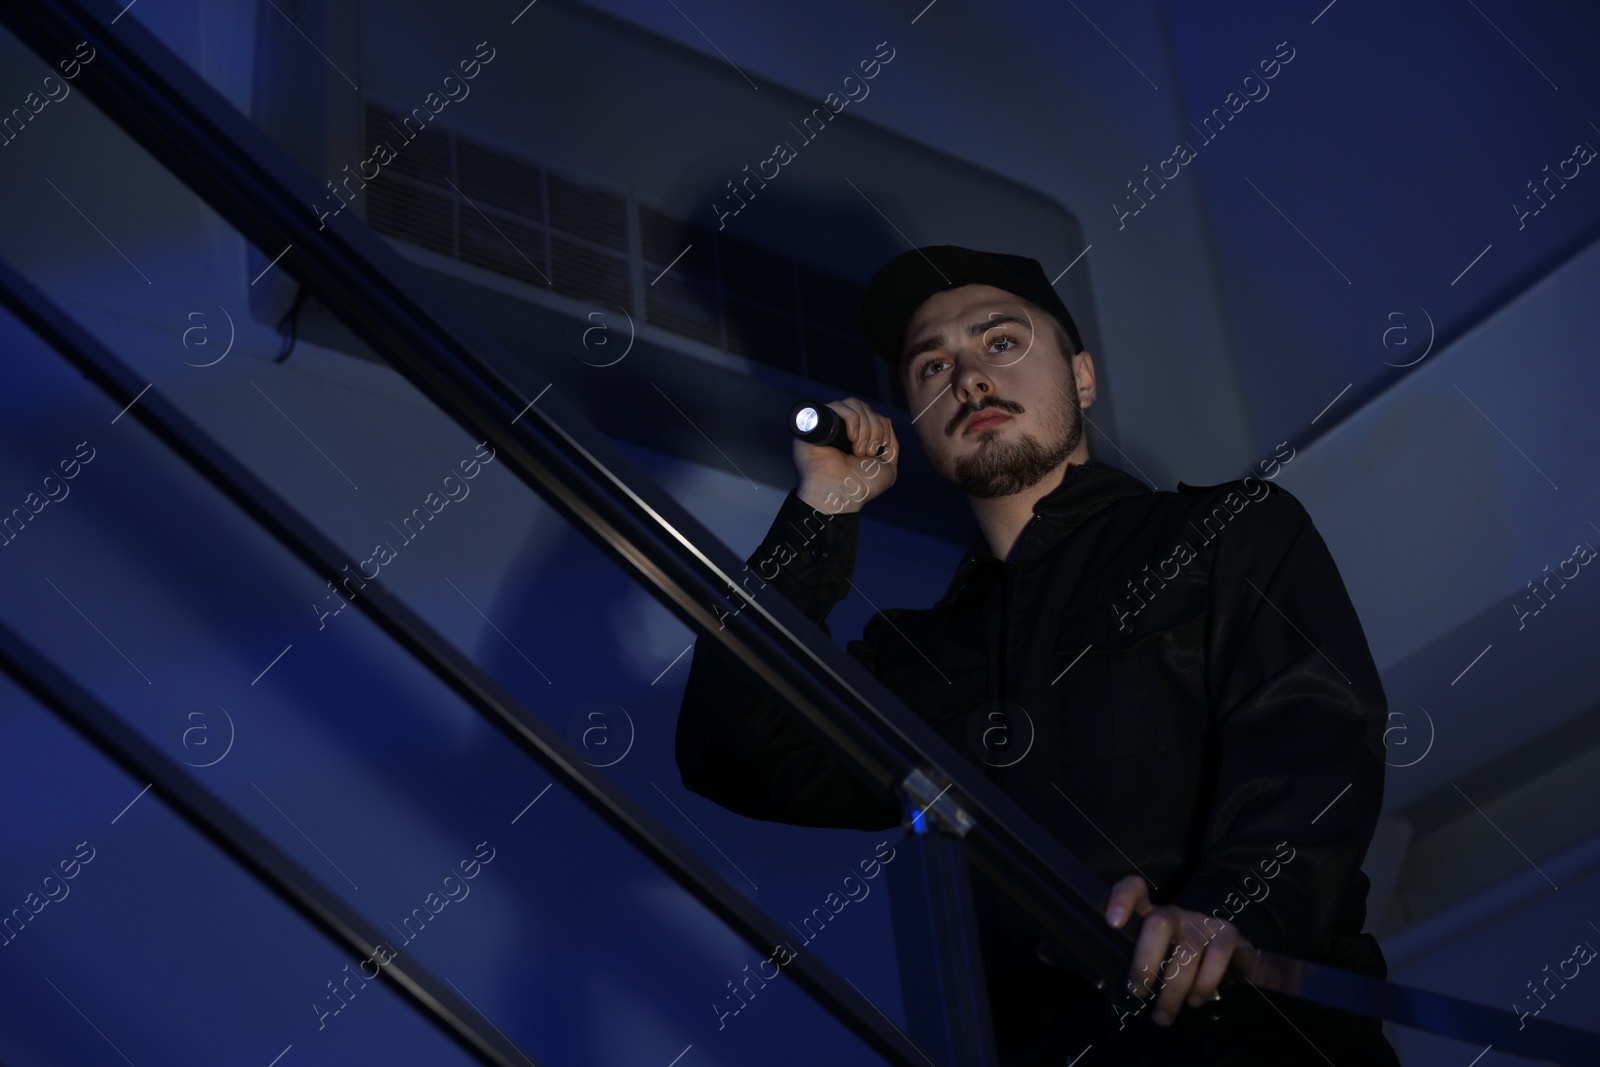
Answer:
[{"left": 365, "top": 102, "right": 886, "bottom": 400}]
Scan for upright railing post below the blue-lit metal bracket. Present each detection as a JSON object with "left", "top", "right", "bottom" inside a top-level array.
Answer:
[{"left": 888, "top": 771, "right": 1000, "bottom": 1067}]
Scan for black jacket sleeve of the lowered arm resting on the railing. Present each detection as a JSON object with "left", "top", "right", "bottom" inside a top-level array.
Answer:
[{"left": 1173, "top": 483, "right": 1387, "bottom": 958}]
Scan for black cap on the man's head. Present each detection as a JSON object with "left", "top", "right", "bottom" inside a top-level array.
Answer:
[{"left": 856, "top": 245, "right": 1083, "bottom": 368}]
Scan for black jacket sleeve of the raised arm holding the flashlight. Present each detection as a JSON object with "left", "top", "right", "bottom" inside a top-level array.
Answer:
[{"left": 675, "top": 491, "right": 901, "bottom": 830}]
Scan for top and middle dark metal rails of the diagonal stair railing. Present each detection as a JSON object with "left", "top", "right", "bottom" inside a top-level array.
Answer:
[{"left": 0, "top": 0, "right": 1600, "bottom": 1065}]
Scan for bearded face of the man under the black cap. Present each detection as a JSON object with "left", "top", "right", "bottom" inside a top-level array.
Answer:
[{"left": 899, "top": 285, "right": 1094, "bottom": 499}]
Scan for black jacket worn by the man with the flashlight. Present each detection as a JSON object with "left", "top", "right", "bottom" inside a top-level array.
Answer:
[{"left": 677, "top": 461, "right": 1392, "bottom": 1062}]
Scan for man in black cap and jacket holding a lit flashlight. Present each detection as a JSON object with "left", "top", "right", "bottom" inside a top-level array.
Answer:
[{"left": 677, "top": 246, "right": 1398, "bottom": 1067}]
